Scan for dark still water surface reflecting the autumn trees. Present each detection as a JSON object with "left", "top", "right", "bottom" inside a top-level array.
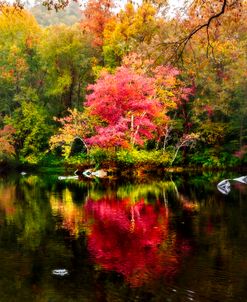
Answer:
[{"left": 0, "top": 173, "right": 247, "bottom": 302}]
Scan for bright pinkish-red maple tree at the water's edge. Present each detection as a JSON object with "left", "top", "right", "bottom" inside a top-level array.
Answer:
[{"left": 86, "top": 67, "right": 160, "bottom": 147}]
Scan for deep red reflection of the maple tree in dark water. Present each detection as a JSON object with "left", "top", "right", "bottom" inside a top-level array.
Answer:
[{"left": 86, "top": 198, "right": 190, "bottom": 286}]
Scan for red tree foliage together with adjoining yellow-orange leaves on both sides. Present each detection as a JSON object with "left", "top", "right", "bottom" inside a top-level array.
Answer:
[{"left": 51, "top": 63, "right": 194, "bottom": 153}]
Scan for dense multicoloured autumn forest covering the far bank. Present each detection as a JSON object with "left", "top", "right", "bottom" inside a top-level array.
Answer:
[{"left": 0, "top": 0, "right": 247, "bottom": 168}]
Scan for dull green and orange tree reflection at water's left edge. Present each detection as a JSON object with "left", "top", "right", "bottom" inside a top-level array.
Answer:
[{"left": 0, "top": 176, "right": 50, "bottom": 250}]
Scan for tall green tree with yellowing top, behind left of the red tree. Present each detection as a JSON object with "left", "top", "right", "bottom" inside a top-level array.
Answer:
[{"left": 39, "top": 25, "right": 94, "bottom": 116}]
